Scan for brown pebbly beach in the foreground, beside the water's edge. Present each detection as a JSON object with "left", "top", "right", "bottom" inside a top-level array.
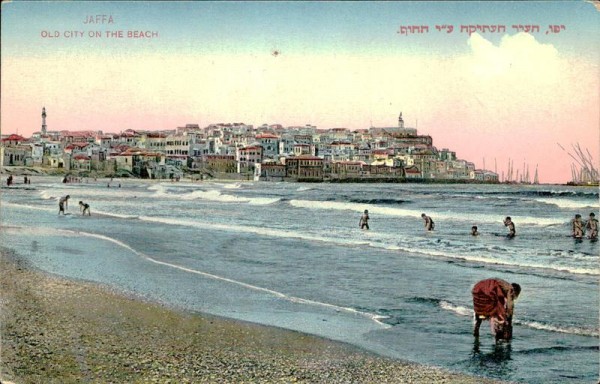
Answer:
[{"left": 0, "top": 249, "right": 501, "bottom": 384}]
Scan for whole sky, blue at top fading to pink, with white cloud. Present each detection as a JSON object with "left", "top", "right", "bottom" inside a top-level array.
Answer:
[{"left": 0, "top": 1, "right": 600, "bottom": 183}]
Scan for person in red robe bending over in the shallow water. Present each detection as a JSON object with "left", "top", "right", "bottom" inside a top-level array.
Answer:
[{"left": 471, "top": 279, "right": 521, "bottom": 340}]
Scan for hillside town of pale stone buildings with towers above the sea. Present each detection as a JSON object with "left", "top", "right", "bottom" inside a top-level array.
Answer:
[{"left": 0, "top": 108, "right": 498, "bottom": 183}]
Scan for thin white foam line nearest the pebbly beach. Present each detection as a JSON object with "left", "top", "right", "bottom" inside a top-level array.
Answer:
[{"left": 11, "top": 227, "right": 390, "bottom": 328}]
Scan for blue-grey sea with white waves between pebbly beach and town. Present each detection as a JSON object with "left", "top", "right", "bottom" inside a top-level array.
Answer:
[{"left": 0, "top": 177, "right": 600, "bottom": 384}]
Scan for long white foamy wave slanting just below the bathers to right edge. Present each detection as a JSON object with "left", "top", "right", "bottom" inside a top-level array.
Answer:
[{"left": 7, "top": 200, "right": 600, "bottom": 276}]
